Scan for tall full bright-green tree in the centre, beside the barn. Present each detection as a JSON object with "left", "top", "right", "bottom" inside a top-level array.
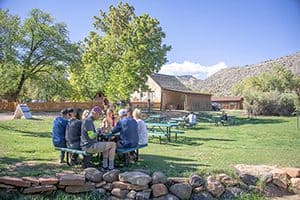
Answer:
[{"left": 72, "top": 2, "right": 171, "bottom": 101}]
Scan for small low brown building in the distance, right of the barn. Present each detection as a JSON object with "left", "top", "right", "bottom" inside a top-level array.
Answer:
[{"left": 211, "top": 96, "right": 244, "bottom": 109}]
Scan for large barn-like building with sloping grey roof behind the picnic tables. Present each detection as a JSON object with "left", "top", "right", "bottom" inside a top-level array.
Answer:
[{"left": 132, "top": 74, "right": 211, "bottom": 111}]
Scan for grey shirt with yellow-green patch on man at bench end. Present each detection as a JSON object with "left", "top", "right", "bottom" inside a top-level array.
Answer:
[{"left": 80, "top": 116, "right": 98, "bottom": 148}]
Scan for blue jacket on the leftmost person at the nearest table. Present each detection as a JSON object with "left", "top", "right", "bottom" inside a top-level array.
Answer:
[{"left": 52, "top": 117, "right": 68, "bottom": 146}]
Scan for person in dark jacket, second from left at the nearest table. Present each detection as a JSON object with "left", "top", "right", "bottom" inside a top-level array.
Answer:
[{"left": 66, "top": 108, "right": 82, "bottom": 163}]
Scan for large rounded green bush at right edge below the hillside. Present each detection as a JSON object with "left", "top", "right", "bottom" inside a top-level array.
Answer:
[{"left": 233, "top": 66, "right": 300, "bottom": 115}]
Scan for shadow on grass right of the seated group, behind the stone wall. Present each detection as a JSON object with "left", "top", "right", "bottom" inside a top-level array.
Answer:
[{"left": 121, "top": 155, "right": 210, "bottom": 176}]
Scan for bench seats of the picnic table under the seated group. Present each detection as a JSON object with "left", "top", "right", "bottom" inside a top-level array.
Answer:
[{"left": 55, "top": 144, "right": 148, "bottom": 168}]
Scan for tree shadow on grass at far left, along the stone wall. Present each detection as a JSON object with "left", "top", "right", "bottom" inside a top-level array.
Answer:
[{"left": 0, "top": 157, "right": 82, "bottom": 177}]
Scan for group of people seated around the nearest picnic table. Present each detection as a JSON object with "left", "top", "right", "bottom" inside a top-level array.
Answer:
[{"left": 52, "top": 106, "right": 148, "bottom": 170}]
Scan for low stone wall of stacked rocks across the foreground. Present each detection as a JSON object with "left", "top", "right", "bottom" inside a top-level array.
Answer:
[{"left": 0, "top": 165, "right": 300, "bottom": 200}]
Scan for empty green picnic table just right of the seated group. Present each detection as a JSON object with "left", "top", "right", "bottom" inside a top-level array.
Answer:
[{"left": 146, "top": 122, "right": 181, "bottom": 142}]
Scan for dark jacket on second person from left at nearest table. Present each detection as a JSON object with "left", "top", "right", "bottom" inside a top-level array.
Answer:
[{"left": 66, "top": 119, "right": 82, "bottom": 149}]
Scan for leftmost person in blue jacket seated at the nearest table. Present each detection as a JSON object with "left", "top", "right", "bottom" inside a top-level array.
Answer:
[{"left": 52, "top": 108, "right": 70, "bottom": 163}]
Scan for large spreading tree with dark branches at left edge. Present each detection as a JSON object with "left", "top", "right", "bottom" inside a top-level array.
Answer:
[{"left": 0, "top": 9, "right": 80, "bottom": 101}]
